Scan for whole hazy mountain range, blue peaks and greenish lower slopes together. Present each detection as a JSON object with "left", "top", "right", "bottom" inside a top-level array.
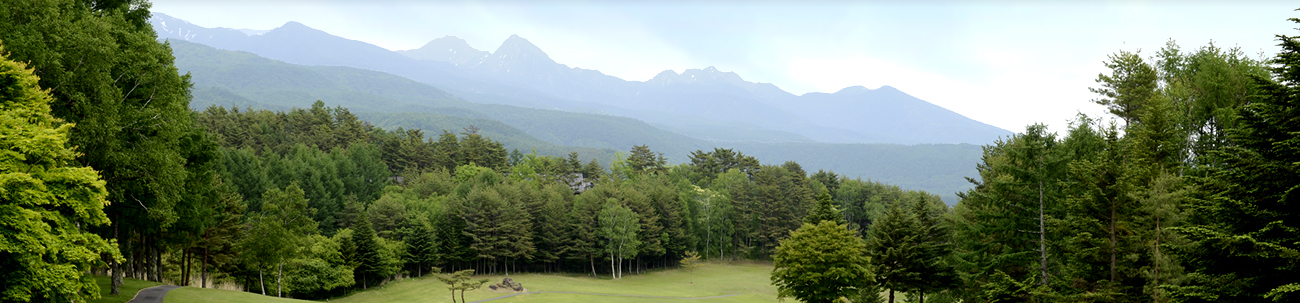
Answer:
[{"left": 152, "top": 13, "right": 1010, "bottom": 203}]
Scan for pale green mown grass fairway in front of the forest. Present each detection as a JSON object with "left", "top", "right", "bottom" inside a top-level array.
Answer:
[{"left": 165, "top": 261, "right": 776, "bottom": 303}]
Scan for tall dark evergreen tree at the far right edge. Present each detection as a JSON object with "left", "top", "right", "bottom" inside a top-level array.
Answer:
[{"left": 1170, "top": 18, "right": 1300, "bottom": 302}]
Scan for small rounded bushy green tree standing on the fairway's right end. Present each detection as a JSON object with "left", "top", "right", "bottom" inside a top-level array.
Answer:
[{"left": 772, "top": 221, "right": 874, "bottom": 302}]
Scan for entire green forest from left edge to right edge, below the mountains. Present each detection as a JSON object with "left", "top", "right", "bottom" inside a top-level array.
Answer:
[{"left": 0, "top": 0, "right": 1300, "bottom": 302}]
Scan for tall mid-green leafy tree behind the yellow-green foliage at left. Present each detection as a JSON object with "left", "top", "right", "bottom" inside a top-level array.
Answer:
[{"left": 0, "top": 0, "right": 194, "bottom": 293}]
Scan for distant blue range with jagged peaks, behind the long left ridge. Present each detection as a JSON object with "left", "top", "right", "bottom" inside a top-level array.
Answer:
[{"left": 399, "top": 35, "right": 1011, "bottom": 144}]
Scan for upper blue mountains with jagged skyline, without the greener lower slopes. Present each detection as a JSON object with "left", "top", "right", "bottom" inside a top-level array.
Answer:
[{"left": 151, "top": 13, "right": 1011, "bottom": 144}]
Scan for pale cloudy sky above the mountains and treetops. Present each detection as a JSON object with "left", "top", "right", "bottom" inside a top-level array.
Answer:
[{"left": 153, "top": 0, "right": 1300, "bottom": 133}]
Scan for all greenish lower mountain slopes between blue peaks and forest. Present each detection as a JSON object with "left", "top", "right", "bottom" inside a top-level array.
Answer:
[{"left": 172, "top": 42, "right": 980, "bottom": 202}]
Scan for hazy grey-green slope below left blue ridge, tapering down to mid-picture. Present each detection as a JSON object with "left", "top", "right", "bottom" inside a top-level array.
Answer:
[{"left": 170, "top": 42, "right": 681, "bottom": 161}]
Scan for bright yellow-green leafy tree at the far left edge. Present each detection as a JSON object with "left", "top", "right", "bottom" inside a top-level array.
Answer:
[{"left": 0, "top": 44, "right": 120, "bottom": 302}]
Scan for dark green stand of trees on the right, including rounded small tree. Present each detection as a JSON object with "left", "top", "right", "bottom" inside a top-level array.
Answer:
[{"left": 772, "top": 18, "right": 1300, "bottom": 302}]
